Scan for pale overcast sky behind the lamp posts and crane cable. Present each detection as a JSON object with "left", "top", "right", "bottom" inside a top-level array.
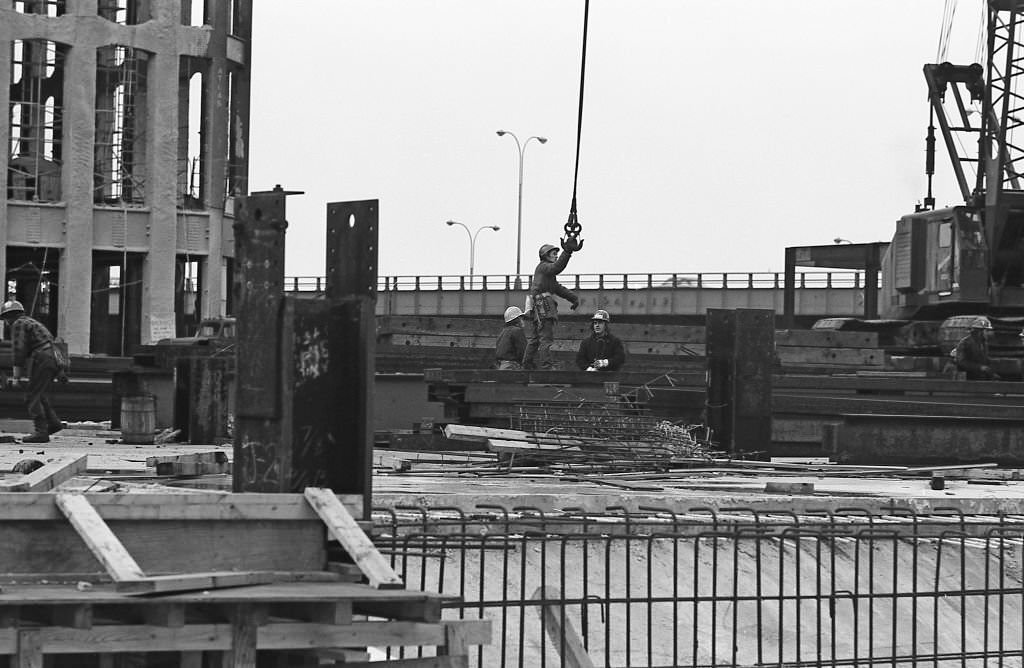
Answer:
[{"left": 250, "top": 0, "right": 980, "bottom": 276}]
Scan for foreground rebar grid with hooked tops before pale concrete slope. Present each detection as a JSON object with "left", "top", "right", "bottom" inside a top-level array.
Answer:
[{"left": 374, "top": 505, "right": 1024, "bottom": 668}]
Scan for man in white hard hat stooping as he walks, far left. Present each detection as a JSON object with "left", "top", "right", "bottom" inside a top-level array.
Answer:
[{"left": 0, "top": 300, "right": 63, "bottom": 443}]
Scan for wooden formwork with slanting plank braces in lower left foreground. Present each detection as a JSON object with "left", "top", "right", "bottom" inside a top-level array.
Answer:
[{"left": 0, "top": 490, "right": 489, "bottom": 668}]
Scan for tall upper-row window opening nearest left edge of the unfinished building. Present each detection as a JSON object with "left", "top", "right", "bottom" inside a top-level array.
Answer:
[{"left": 7, "top": 40, "right": 67, "bottom": 202}]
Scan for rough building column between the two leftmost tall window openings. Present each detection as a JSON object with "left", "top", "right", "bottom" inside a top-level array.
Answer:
[{"left": 57, "top": 0, "right": 96, "bottom": 352}]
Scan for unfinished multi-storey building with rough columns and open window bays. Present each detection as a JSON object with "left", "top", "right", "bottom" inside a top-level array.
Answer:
[{"left": 0, "top": 0, "right": 252, "bottom": 354}]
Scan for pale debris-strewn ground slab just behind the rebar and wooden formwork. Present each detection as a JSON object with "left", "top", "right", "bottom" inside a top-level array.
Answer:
[{"left": 6, "top": 420, "right": 1024, "bottom": 514}]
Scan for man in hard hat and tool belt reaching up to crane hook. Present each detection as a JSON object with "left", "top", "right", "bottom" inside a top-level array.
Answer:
[{"left": 522, "top": 240, "right": 583, "bottom": 369}]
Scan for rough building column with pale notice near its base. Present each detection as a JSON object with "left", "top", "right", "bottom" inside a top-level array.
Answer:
[{"left": 141, "top": 0, "right": 181, "bottom": 343}]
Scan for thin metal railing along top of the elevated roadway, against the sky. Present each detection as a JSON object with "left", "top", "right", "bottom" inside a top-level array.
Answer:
[{"left": 285, "top": 270, "right": 864, "bottom": 292}]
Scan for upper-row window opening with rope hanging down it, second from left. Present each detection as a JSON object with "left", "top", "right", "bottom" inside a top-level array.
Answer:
[{"left": 93, "top": 45, "right": 148, "bottom": 206}]
